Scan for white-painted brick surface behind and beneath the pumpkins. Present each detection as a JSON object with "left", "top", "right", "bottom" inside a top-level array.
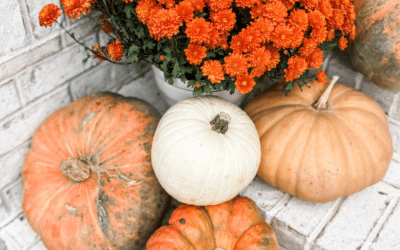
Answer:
[{"left": 0, "top": 0, "right": 400, "bottom": 250}]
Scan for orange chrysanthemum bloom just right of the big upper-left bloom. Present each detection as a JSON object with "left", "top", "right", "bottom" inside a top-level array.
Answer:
[{"left": 185, "top": 17, "right": 211, "bottom": 44}]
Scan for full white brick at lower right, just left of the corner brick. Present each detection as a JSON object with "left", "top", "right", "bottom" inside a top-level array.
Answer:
[{"left": 312, "top": 186, "right": 393, "bottom": 250}]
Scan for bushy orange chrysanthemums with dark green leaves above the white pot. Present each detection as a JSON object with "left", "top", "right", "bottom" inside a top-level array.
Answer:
[{"left": 39, "top": 0, "right": 356, "bottom": 95}]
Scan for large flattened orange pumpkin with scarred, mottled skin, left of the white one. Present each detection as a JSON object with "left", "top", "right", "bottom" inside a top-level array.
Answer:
[{"left": 22, "top": 93, "right": 170, "bottom": 250}]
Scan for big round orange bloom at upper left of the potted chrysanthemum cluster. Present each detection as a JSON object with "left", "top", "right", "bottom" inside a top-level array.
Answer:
[{"left": 147, "top": 9, "right": 183, "bottom": 40}]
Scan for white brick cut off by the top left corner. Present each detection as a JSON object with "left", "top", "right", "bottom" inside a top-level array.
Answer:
[{"left": 0, "top": 0, "right": 27, "bottom": 56}]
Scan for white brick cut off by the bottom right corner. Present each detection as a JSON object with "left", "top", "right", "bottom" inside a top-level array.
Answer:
[{"left": 369, "top": 199, "right": 400, "bottom": 250}]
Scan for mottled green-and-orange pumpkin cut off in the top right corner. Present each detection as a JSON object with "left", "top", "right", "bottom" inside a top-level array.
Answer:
[{"left": 349, "top": 0, "right": 400, "bottom": 91}]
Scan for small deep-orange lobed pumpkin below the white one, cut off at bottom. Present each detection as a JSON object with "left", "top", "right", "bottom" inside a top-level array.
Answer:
[{"left": 146, "top": 197, "right": 279, "bottom": 250}]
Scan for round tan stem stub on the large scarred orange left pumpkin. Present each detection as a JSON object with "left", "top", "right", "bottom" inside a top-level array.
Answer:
[{"left": 60, "top": 158, "right": 90, "bottom": 182}]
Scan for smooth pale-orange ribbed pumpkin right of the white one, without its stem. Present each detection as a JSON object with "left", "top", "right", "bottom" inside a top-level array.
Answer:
[{"left": 245, "top": 79, "right": 393, "bottom": 202}]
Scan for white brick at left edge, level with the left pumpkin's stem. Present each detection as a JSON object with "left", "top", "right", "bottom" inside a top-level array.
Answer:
[{"left": 0, "top": 143, "right": 29, "bottom": 189}]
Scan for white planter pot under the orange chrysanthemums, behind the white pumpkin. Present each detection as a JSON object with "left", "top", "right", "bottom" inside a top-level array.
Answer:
[{"left": 151, "top": 65, "right": 246, "bottom": 107}]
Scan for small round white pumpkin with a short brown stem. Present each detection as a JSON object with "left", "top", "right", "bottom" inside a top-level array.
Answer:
[{"left": 151, "top": 96, "right": 261, "bottom": 206}]
